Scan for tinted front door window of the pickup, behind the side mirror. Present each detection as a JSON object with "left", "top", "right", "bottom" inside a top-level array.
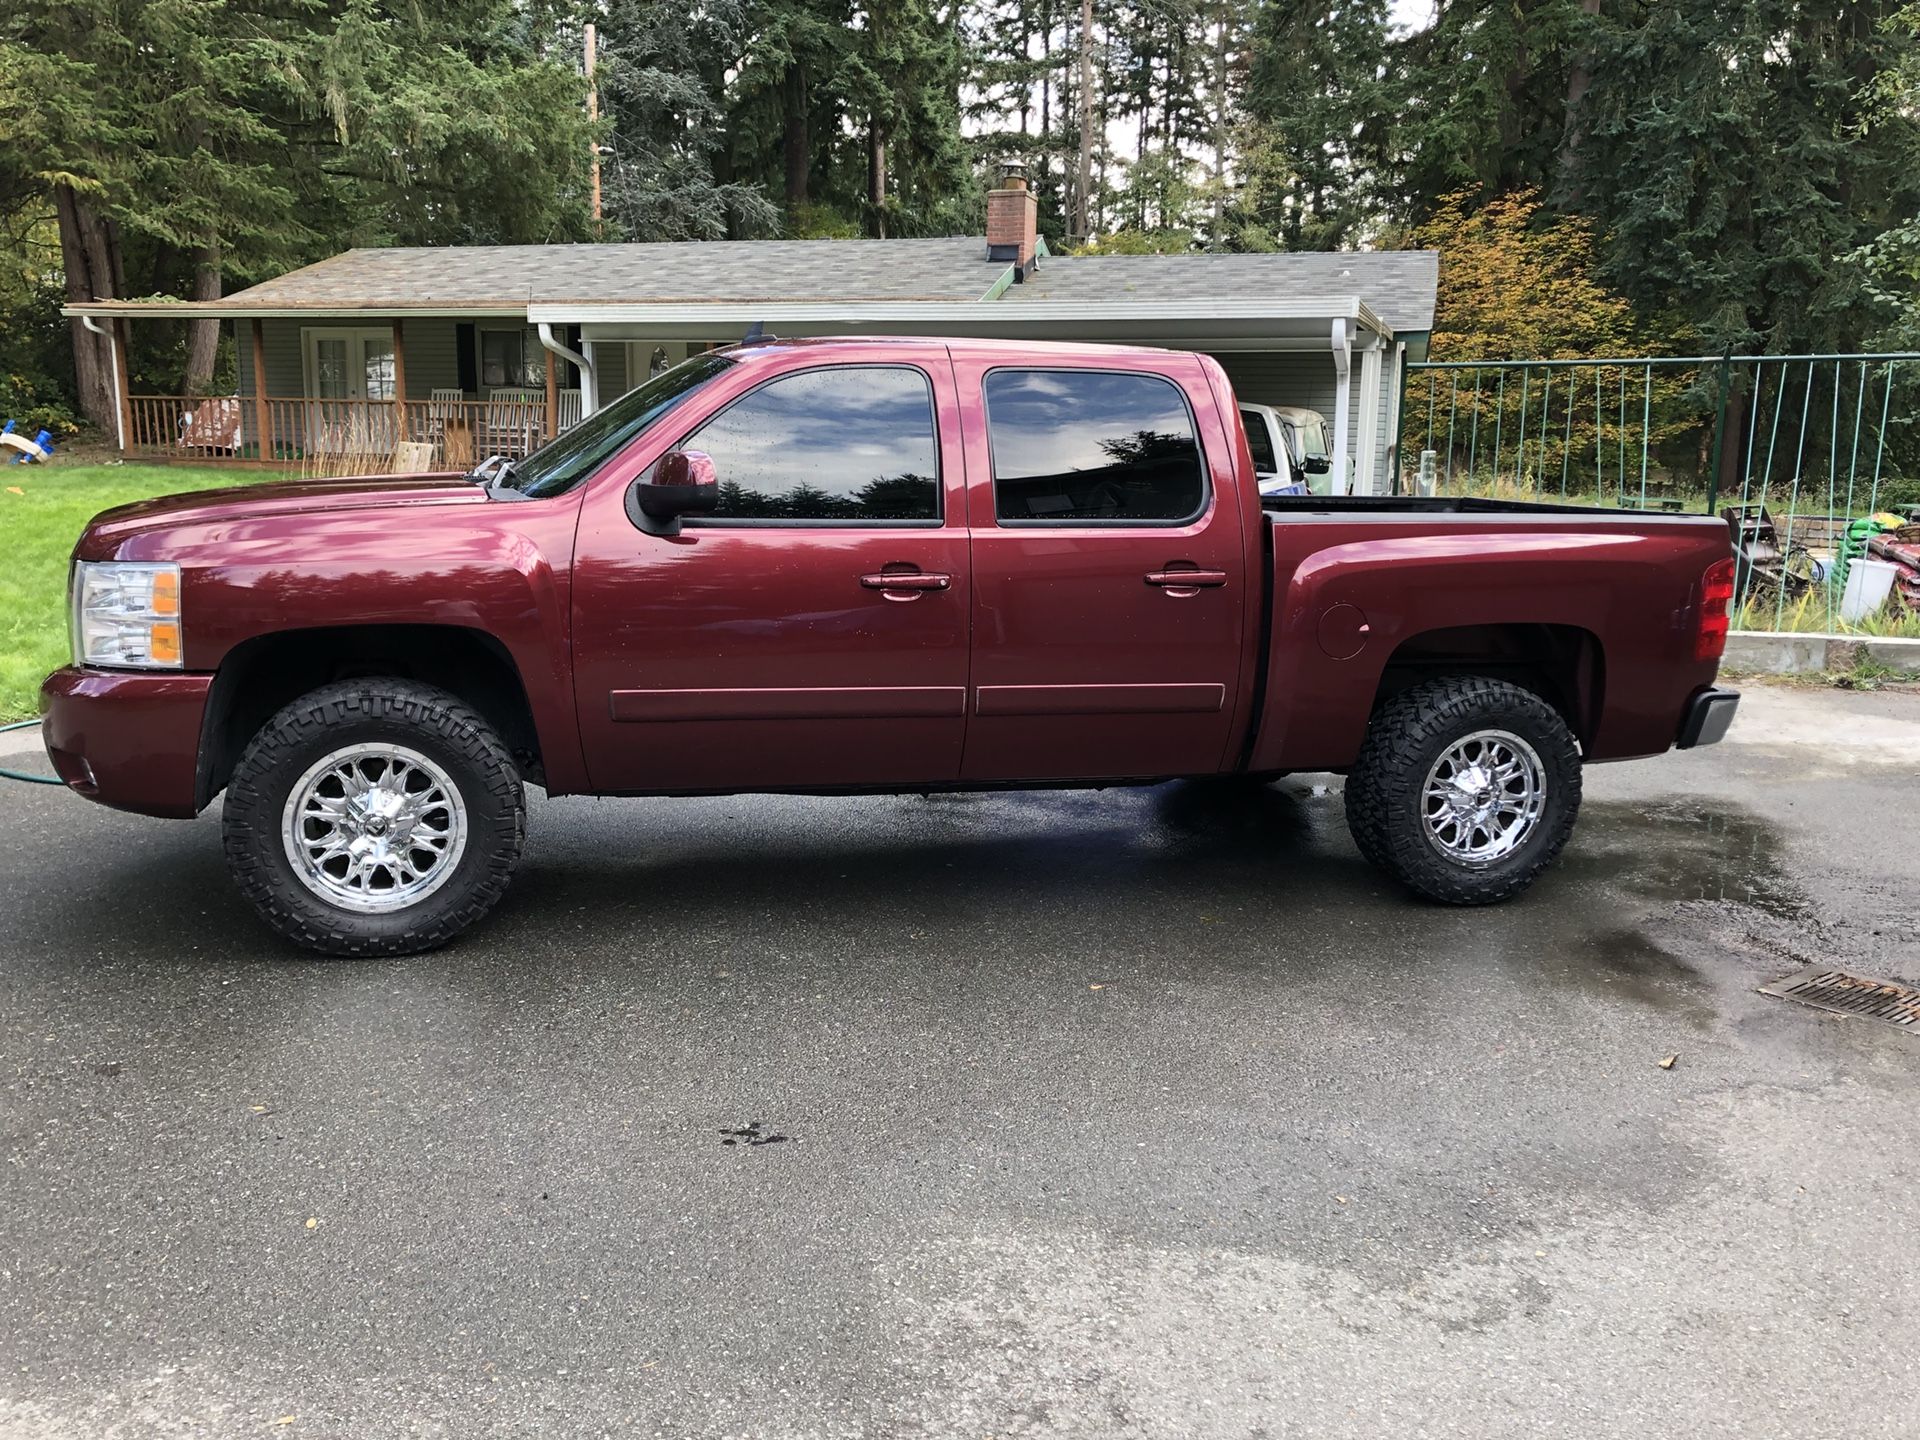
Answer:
[{"left": 682, "top": 367, "right": 941, "bottom": 520}]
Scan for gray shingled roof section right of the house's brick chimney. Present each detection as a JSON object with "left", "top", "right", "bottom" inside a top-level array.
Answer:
[{"left": 1006, "top": 250, "right": 1440, "bottom": 334}]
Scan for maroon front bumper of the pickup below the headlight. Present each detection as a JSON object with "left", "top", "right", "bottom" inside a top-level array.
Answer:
[{"left": 40, "top": 664, "right": 213, "bottom": 820}]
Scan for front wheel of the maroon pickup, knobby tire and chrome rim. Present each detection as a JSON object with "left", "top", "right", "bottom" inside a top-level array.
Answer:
[{"left": 221, "top": 680, "right": 526, "bottom": 956}]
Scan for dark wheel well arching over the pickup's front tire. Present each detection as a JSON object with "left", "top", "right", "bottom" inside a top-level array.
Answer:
[{"left": 198, "top": 626, "right": 545, "bottom": 806}]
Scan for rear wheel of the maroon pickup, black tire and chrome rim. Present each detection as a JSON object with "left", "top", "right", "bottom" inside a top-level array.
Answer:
[{"left": 1346, "top": 676, "right": 1580, "bottom": 904}]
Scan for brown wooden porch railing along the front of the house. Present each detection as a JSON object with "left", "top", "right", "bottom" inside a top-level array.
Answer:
[{"left": 127, "top": 390, "right": 580, "bottom": 474}]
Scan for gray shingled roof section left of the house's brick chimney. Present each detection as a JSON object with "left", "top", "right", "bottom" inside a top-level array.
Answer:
[{"left": 228, "top": 236, "right": 1006, "bottom": 309}]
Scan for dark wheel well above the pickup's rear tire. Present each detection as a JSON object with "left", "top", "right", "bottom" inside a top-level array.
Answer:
[{"left": 1373, "top": 624, "right": 1605, "bottom": 745}]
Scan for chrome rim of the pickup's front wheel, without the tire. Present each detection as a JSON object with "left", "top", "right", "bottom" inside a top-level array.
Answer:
[{"left": 280, "top": 743, "right": 467, "bottom": 914}]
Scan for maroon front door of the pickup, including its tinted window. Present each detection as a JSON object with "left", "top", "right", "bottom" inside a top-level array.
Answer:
[{"left": 574, "top": 348, "right": 970, "bottom": 791}]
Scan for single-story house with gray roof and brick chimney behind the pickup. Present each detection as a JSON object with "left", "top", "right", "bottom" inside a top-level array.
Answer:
[{"left": 63, "top": 175, "right": 1438, "bottom": 492}]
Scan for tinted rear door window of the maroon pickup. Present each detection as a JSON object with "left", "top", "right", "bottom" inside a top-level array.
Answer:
[{"left": 985, "top": 371, "right": 1206, "bottom": 522}]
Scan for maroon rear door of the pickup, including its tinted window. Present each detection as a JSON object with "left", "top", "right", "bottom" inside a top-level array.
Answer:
[{"left": 954, "top": 351, "right": 1258, "bottom": 780}]
